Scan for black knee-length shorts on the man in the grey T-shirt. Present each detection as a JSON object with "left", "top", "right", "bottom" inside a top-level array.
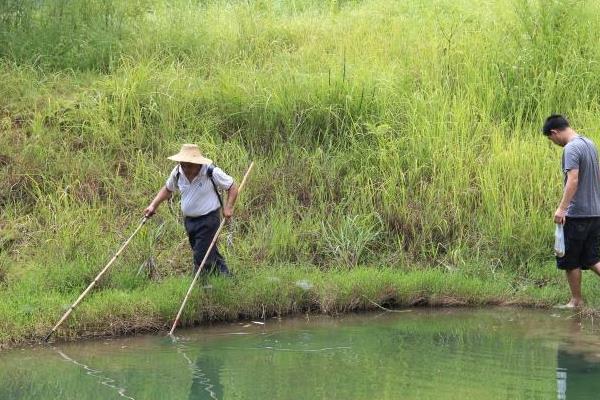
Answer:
[{"left": 556, "top": 217, "right": 600, "bottom": 270}]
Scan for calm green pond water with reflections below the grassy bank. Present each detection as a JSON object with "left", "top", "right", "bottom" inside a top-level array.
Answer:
[{"left": 0, "top": 308, "right": 600, "bottom": 400}]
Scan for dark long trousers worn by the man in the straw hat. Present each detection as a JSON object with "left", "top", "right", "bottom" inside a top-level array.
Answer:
[{"left": 184, "top": 209, "right": 229, "bottom": 275}]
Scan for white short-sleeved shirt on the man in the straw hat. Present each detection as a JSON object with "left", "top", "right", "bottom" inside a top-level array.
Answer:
[{"left": 165, "top": 165, "right": 233, "bottom": 217}]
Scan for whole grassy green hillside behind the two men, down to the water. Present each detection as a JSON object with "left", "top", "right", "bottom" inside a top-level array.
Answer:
[{"left": 0, "top": 0, "right": 600, "bottom": 343}]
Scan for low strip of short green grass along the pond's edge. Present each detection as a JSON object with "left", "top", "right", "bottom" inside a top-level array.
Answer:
[{"left": 0, "top": 266, "right": 584, "bottom": 346}]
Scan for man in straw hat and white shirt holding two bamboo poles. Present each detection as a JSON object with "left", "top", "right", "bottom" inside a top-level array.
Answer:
[{"left": 144, "top": 144, "right": 238, "bottom": 276}]
